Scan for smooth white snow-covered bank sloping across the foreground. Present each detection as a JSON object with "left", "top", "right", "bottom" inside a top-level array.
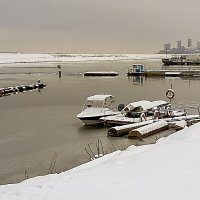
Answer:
[{"left": 0, "top": 124, "right": 200, "bottom": 200}]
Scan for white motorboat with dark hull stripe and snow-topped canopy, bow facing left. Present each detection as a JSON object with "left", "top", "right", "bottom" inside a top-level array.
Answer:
[{"left": 77, "top": 95, "right": 120, "bottom": 125}]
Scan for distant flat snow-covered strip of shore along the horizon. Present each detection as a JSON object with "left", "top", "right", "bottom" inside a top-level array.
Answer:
[{"left": 0, "top": 53, "right": 165, "bottom": 64}]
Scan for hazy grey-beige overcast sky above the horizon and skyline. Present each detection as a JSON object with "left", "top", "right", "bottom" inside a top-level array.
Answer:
[{"left": 0, "top": 0, "right": 200, "bottom": 53}]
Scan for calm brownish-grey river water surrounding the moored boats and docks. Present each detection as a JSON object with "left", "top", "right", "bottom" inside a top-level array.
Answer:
[{"left": 0, "top": 60, "right": 200, "bottom": 184}]
